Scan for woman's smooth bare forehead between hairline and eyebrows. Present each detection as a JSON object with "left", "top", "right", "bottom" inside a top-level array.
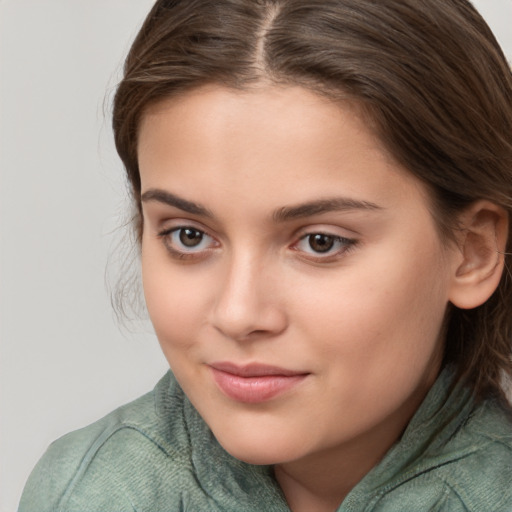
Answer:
[{"left": 138, "top": 86, "right": 427, "bottom": 216}]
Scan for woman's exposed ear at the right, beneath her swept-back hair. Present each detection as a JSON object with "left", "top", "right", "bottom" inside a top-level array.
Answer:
[{"left": 449, "top": 200, "right": 508, "bottom": 309}]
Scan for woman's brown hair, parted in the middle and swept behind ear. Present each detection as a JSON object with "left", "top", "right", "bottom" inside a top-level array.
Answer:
[{"left": 113, "top": 0, "right": 512, "bottom": 399}]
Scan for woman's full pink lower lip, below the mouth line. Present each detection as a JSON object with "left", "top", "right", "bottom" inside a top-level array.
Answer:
[{"left": 212, "top": 368, "right": 307, "bottom": 404}]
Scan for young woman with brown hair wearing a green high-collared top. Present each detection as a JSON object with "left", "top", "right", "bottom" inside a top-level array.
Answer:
[{"left": 20, "top": 0, "right": 512, "bottom": 512}]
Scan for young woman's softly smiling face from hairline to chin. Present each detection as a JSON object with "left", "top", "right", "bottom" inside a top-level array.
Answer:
[{"left": 138, "top": 87, "right": 456, "bottom": 466}]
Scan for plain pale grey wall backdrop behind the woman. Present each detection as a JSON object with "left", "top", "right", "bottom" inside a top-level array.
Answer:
[{"left": 0, "top": 0, "right": 512, "bottom": 512}]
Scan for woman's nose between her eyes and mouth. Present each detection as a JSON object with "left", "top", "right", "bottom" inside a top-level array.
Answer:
[{"left": 212, "top": 251, "right": 287, "bottom": 341}]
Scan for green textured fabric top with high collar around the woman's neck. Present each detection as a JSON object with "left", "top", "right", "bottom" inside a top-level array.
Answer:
[{"left": 19, "top": 370, "right": 512, "bottom": 512}]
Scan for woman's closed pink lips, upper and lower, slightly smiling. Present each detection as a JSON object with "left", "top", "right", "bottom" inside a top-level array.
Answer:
[{"left": 209, "top": 362, "right": 309, "bottom": 404}]
